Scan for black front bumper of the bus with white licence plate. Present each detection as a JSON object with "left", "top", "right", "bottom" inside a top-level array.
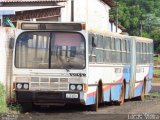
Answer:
[{"left": 15, "top": 91, "right": 81, "bottom": 104}]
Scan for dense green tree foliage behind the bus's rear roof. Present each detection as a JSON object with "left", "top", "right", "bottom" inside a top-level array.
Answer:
[{"left": 110, "top": 0, "right": 160, "bottom": 41}]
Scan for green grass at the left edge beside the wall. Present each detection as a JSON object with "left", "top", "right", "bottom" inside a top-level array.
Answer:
[{"left": 0, "top": 83, "right": 8, "bottom": 113}]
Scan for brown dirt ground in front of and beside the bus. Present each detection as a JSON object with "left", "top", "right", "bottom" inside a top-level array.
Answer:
[{"left": 0, "top": 86, "right": 160, "bottom": 120}]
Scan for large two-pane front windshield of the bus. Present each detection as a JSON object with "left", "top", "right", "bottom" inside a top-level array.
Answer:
[{"left": 15, "top": 32, "right": 85, "bottom": 69}]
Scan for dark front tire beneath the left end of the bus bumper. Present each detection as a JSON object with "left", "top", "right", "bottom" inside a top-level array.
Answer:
[{"left": 20, "top": 102, "right": 32, "bottom": 113}]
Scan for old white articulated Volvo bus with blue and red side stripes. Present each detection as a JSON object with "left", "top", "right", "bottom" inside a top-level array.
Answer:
[{"left": 7, "top": 21, "right": 153, "bottom": 111}]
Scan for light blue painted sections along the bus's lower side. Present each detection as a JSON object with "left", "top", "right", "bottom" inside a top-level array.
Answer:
[{"left": 86, "top": 65, "right": 153, "bottom": 105}]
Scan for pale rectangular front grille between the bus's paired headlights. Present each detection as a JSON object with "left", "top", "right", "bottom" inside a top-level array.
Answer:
[{"left": 30, "top": 77, "right": 69, "bottom": 91}]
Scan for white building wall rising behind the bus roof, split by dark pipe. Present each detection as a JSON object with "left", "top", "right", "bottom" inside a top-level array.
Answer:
[{"left": 61, "top": 0, "right": 110, "bottom": 31}]
